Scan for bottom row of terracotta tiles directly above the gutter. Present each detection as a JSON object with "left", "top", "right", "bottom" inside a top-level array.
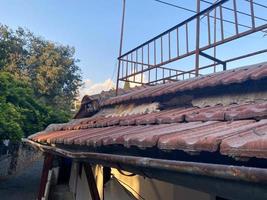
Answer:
[{"left": 29, "top": 120, "right": 267, "bottom": 158}]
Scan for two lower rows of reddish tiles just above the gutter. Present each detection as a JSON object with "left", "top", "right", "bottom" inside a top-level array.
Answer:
[{"left": 31, "top": 102, "right": 267, "bottom": 158}]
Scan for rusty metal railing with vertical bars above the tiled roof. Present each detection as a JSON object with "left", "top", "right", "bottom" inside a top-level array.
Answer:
[{"left": 117, "top": 0, "right": 267, "bottom": 90}]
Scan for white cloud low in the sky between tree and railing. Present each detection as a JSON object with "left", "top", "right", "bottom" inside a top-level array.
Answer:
[{"left": 79, "top": 79, "right": 115, "bottom": 99}]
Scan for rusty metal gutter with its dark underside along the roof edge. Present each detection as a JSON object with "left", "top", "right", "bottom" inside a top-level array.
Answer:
[{"left": 23, "top": 139, "right": 267, "bottom": 200}]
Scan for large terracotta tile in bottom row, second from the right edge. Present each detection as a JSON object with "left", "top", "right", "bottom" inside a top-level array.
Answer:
[{"left": 158, "top": 120, "right": 255, "bottom": 152}]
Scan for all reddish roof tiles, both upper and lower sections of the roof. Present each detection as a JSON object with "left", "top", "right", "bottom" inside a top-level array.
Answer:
[{"left": 29, "top": 64, "right": 267, "bottom": 162}]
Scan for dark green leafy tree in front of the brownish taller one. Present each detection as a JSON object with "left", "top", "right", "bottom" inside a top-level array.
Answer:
[{"left": 0, "top": 72, "right": 70, "bottom": 141}]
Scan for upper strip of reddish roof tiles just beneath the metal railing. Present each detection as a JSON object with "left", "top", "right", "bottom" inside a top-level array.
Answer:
[{"left": 103, "top": 63, "right": 267, "bottom": 106}]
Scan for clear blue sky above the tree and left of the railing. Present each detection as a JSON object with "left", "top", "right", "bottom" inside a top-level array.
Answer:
[{"left": 0, "top": 0, "right": 266, "bottom": 89}]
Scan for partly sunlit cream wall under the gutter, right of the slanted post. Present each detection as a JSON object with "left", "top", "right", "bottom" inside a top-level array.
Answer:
[{"left": 104, "top": 168, "right": 213, "bottom": 200}]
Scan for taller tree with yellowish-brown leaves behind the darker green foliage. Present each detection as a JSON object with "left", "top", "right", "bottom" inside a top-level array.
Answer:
[{"left": 0, "top": 25, "right": 81, "bottom": 110}]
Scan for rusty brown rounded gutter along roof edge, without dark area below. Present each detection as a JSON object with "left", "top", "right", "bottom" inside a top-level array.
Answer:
[{"left": 23, "top": 139, "right": 267, "bottom": 184}]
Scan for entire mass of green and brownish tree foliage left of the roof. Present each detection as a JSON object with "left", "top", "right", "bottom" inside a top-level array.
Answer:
[{"left": 0, "top": 25, "right": 81, "bottom": 140}]
